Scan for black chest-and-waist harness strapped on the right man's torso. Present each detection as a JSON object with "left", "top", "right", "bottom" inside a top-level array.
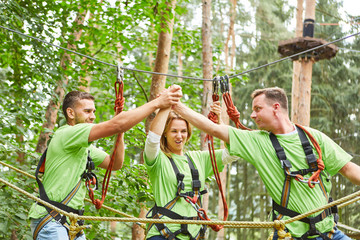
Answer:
[{"left": 269, "top": 124, "right": 337, "bottom": 240}]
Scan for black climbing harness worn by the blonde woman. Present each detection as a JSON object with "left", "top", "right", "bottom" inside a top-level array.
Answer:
[{"left": 146, "top": 154, "right": 208, "bottom": 240}]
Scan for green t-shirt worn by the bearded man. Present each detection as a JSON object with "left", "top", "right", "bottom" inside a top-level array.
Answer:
[{"left": 29, "top": 123, "right": 107, "bottom": 219}]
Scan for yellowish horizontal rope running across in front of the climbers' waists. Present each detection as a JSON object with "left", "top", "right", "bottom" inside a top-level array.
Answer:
[{"left": 0, "top": 161, "right": 360, "bottom": 240}]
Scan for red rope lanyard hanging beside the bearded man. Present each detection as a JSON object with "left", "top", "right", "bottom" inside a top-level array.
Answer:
[{"left": 86, "top": 65, "right": 125, "bottom": 209}]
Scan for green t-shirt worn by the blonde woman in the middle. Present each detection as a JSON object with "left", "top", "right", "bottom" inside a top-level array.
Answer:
[{"left": 144, "top": 150, "right": 224, "bottom": 240}]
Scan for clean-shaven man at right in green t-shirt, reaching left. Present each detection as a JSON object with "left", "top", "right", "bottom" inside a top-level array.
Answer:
[{"left": 174, "top": 88, "right": 360, "bottom": 240}]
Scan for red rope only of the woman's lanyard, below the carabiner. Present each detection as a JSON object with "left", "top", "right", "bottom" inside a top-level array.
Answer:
[{"left": 202, "top": 93, "right": 229, "bottom": 232}]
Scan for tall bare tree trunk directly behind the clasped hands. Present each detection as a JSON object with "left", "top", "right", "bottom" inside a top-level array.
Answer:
[{"left": 132, "top": 0, "right": 176, "bottom": 240}]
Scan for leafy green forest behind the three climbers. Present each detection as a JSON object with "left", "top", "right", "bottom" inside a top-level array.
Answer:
[{"left": 0, "top": 0, "right": 360, "bottom": 240}]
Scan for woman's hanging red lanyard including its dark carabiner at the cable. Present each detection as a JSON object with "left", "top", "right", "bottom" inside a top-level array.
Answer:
[{"left": 203, "top": 77, "right": 229, "bottom": 232}]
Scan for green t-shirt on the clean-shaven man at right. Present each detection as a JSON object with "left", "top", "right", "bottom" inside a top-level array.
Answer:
[{"left": 227, "top": 127, "right": 352, "bottom": 237}]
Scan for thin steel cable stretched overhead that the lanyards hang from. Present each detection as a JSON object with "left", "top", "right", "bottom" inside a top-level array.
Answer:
[{"left": 0, "top": 25, "right": 360, "bottom": 81}]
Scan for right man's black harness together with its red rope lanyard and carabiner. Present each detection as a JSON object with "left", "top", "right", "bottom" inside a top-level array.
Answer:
[{"left": 220, "top": 80, "right": 338, "bottom": 240}]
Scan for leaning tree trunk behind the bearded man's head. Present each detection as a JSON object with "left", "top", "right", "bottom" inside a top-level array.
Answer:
[{"left": 36, "top": 12, "right": 86, "bottom": 153}]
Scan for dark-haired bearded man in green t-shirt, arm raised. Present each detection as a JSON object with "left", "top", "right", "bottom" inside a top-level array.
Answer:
[{"left": 29, "top": 86, "right": 182, "bottom": 240}]
